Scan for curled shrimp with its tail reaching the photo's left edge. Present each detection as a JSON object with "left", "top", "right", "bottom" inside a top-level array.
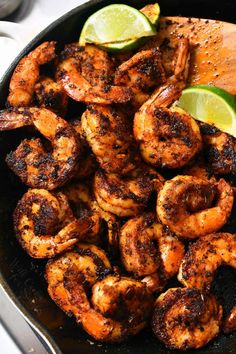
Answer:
[{"left": 0, "top": 107, "right": 80, "bottom": 190}]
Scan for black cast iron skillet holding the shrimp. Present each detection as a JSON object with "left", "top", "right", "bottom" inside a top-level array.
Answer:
[{"left": 0, "top": 0, "right": 236, "bottom": 354}]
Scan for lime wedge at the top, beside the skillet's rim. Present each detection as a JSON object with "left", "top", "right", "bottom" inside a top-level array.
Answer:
[{"left": 79, "top": 4, "right": 156, "bottom": 50}]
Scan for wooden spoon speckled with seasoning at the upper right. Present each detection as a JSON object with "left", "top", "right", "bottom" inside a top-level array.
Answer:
[{"left": 152, "top": 17, "right": 236, "bottom": 95}]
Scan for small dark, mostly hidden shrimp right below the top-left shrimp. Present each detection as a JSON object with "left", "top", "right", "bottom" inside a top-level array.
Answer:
[{"left": 35, "top": 77, "right": 68, "bottom": 117}]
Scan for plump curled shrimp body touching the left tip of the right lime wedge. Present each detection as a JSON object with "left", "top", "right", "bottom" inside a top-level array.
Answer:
[{"left": 134, "top": 94, "right": 202, "bottom": 169}]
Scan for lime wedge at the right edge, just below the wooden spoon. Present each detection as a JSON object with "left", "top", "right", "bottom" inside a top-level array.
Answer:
[{"left": 177, "top": 85, "right": 236, "bottom": 137}]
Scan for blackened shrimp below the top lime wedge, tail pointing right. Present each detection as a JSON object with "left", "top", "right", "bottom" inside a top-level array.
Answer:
[{"left": 56, "top": 44, "right": 132, "bottom": 104}]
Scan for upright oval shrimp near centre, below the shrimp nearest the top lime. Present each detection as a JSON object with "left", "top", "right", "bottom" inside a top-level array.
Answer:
[{"left": 81, "top": 105, "right": 137, "bottom": 174}]
